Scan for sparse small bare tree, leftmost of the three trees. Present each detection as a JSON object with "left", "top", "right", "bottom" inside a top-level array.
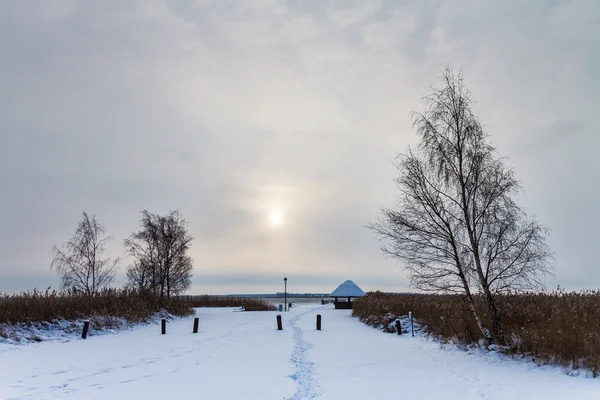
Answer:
[{"left": 50, "top": 212, "right": 119, "bottom": 296}]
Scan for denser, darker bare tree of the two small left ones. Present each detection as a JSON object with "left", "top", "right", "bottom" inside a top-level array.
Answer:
[{"left": 124, "top": 210, "right": 193, "bottom": 297}]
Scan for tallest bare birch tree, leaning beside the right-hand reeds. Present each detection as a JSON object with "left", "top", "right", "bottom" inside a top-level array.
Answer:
[{"left": 370, "top": 68, "right": 552, "bottom": 341}]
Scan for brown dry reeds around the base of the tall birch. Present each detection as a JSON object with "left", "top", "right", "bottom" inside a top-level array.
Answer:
[{"left": 353, "top": 291, "right": 600, "bottom": 377}]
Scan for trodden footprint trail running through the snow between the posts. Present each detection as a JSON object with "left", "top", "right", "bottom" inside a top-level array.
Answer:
[{"left": 288, "top": 309, "right": 319, "bottom": 400}]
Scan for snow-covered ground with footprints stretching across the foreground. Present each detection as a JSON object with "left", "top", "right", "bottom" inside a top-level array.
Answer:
[{"left": 0, "top": 304, "right": 600, "bottom": 400}]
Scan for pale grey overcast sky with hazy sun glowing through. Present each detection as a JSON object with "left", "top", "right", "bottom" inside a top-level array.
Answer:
[{"left": 0, "top": 0, "right": 600, "bottom": 294}]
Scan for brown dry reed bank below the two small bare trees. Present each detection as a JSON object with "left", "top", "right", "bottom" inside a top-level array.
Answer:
[{"left": 0, "top": 289, "right": 275, "bottom": 342}]
